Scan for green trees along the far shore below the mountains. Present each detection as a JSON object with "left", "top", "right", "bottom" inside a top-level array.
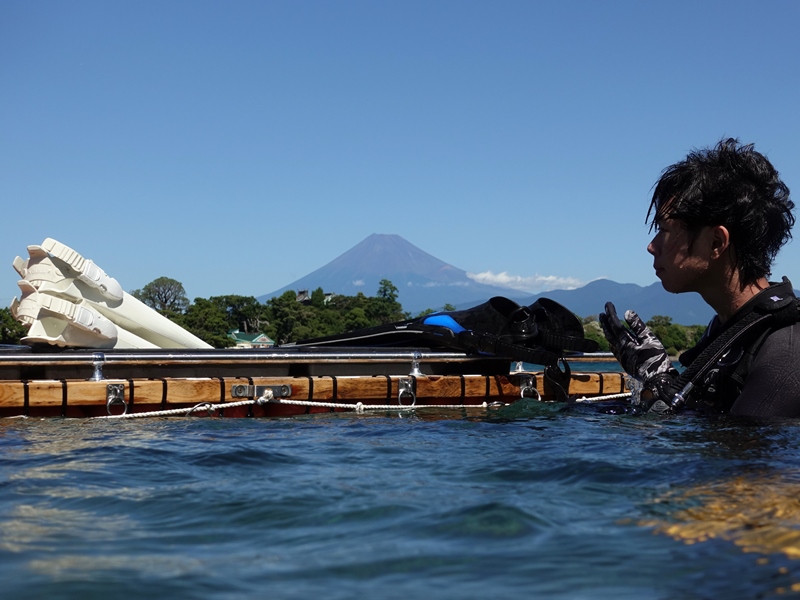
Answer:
[{"left": 0, "top": 277, "right": 705, "bottom": 356}]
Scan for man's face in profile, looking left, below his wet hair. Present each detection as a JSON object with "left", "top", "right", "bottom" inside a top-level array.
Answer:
[{"left": 647, "top": 219, "right": 712, "bottom": 294}]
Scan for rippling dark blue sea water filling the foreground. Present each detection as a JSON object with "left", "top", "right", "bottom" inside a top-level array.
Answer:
[{"left": 0, "top": 410, "right": 800, "bottom": 599}]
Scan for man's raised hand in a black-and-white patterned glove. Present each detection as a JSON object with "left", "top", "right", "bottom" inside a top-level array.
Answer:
[{"left": 600, "top": 302, "right": 673, "bottom": 381}]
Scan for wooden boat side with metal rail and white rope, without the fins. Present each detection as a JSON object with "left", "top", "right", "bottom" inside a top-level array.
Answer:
[{"left": 0, "top": 346, "right": 628, "bottom": 418}]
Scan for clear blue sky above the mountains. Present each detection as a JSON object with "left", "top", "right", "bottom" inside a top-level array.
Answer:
[{"left": 0, "top": 0, "right": 800, "bottom": 311}]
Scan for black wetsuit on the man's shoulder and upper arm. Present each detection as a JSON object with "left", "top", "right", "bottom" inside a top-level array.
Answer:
[{"left": 680, "top": 278, "right": 800, "bottom": 417}]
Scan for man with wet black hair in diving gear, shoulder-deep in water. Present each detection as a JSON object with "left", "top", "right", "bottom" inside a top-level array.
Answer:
[{"left": 600, "top": 139, "right": 800, "bottom": 417}]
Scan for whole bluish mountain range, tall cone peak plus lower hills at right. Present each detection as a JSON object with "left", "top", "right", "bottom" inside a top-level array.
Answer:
[{"left": 258, "top": 233, "right": 714, "bottom": 325}]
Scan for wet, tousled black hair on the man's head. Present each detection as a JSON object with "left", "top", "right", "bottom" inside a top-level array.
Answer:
[{"left": 645, "top": 138, "right": 795, "bottom": 285}]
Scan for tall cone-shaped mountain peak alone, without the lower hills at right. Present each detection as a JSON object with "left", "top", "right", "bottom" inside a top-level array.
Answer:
[{"left": 258, "top": 233, "right": 526, "bottom": 314}]
